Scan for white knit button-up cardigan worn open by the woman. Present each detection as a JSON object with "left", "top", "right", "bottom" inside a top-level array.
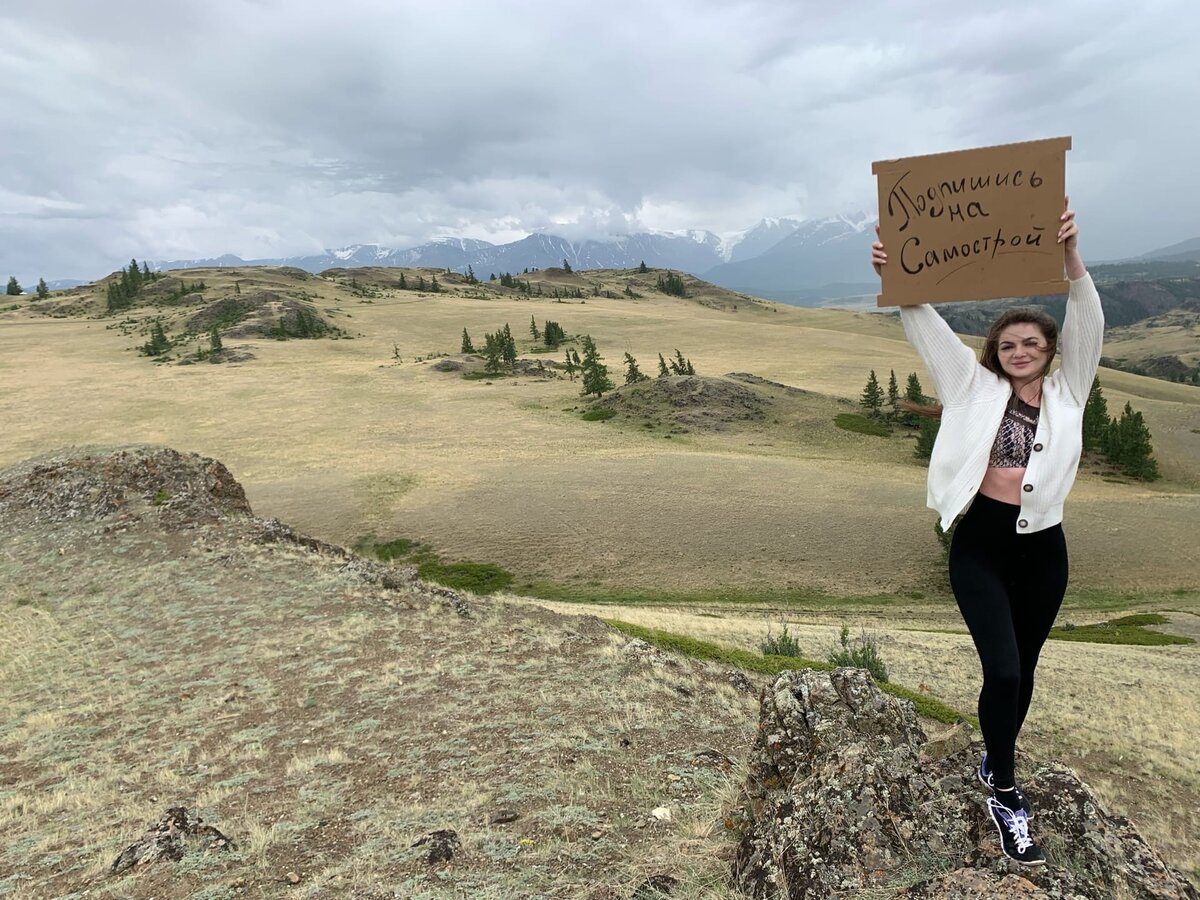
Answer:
[{"left": 900, "top": 274, "right": 1104, "bottom": 534}]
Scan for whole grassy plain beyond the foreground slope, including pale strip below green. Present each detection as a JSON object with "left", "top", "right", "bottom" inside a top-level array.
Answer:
[{"left": 0, "top": 269, "right": 1200, "bottom": 897}]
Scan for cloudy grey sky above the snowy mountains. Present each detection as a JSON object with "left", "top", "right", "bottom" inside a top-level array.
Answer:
[{"left": 0, "top": 0, "right": 1200, "bottom": 286}]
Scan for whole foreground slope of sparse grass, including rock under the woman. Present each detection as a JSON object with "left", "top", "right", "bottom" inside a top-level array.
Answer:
[{"left": 0, "top": 446, "right": 1198, "bottom": 900}]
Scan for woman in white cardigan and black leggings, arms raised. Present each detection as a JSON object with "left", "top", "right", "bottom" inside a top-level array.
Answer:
[{"left": 871, "top": 209, "right": 1104, "bottom": 865}]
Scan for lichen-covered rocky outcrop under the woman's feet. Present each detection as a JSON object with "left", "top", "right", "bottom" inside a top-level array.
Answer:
[{"left": 733, "top": 668, "right": 1200, "bottom": 900}]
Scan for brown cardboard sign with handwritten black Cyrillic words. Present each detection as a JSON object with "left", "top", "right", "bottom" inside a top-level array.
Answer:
[{"left": 871, "top": 137, "right": 1070, "bottom": 306}]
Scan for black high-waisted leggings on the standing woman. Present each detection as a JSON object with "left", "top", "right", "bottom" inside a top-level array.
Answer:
[{"left": 950, "top": 494, "right": 1067, "bottom": 787}]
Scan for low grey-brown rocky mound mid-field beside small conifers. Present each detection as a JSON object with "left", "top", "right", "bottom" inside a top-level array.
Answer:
[{"left": 593, "top": 376, "right": 768, "bottom": 431}]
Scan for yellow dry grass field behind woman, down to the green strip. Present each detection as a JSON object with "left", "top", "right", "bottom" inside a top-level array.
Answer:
[{"left": 0, "top": 264, "right": 1200, "bottom": 594}]
